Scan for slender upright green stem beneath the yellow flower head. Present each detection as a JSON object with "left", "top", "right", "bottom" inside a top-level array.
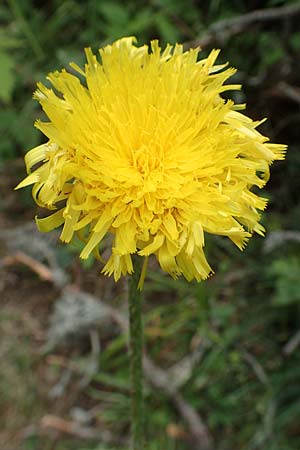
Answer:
[{"left": 128, "top": 255, "right": 144, "bottom": 450}]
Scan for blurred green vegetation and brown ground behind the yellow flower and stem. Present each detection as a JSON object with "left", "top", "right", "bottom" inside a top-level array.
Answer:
[{"left": 0, "top": 0, "right": 300, "bottom": 450}]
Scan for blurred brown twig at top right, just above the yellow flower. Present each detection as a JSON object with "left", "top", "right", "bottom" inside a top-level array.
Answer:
[{"left": 185, "top": 3, "right": 300, "bottom": 48}]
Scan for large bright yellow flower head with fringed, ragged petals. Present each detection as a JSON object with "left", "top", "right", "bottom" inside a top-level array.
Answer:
[{"left": 18, "top": 37, "right": 285, "bottom": 281}]
